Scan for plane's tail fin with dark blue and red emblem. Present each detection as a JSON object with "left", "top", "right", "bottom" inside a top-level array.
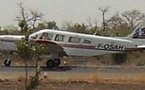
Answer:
[{"left": 126, "top": 19, "right": 145, "bottom": 39}]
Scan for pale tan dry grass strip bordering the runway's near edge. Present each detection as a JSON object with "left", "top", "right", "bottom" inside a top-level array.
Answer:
[{"left": 0, "top": 73, "right": 145, "bottom": 84}]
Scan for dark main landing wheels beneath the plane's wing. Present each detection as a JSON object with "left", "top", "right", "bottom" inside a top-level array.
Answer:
[{"left": 46, "top": 58, "right": 61, "bottom": 68}]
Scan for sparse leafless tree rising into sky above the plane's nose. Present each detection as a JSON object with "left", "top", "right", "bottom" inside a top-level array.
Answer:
[{"left": 16, "top": 3, "right": 43, "bottom": 32}]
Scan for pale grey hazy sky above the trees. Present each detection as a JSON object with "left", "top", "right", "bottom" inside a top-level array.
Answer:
[{"left": 0, "top": 0, "right": 145, "bottom": 27}]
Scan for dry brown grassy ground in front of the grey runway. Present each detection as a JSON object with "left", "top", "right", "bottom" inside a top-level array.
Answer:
[{"left": 0, "top": 72, "right": 145, "bottom": 90}]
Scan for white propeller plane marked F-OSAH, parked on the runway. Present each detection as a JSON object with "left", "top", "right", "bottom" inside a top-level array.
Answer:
[{"left": 0, "top": 20, "right": 145, "bottom": 68}]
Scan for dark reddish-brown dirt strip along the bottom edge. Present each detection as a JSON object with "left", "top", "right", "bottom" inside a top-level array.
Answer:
[{"left": 0, "top": 80, "right": 145, "bottom": 90}]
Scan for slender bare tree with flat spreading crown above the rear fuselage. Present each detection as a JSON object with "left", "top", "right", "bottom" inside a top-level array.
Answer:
[{"left": 98, "top": 7, "right": 110, "bottom": 31}]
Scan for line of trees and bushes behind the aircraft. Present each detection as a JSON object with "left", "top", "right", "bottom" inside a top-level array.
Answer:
[{"left": 0, "top": 3, "right": 145, "bottom": 36}]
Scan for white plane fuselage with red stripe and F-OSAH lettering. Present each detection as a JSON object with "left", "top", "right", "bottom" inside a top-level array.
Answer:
[{"left": 29, "top": 29, "right": 139, "bottom": 56}]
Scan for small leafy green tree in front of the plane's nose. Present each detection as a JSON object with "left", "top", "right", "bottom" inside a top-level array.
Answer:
[{"left": 16, "top": 39, "right": 46, "bottom": 90}]
